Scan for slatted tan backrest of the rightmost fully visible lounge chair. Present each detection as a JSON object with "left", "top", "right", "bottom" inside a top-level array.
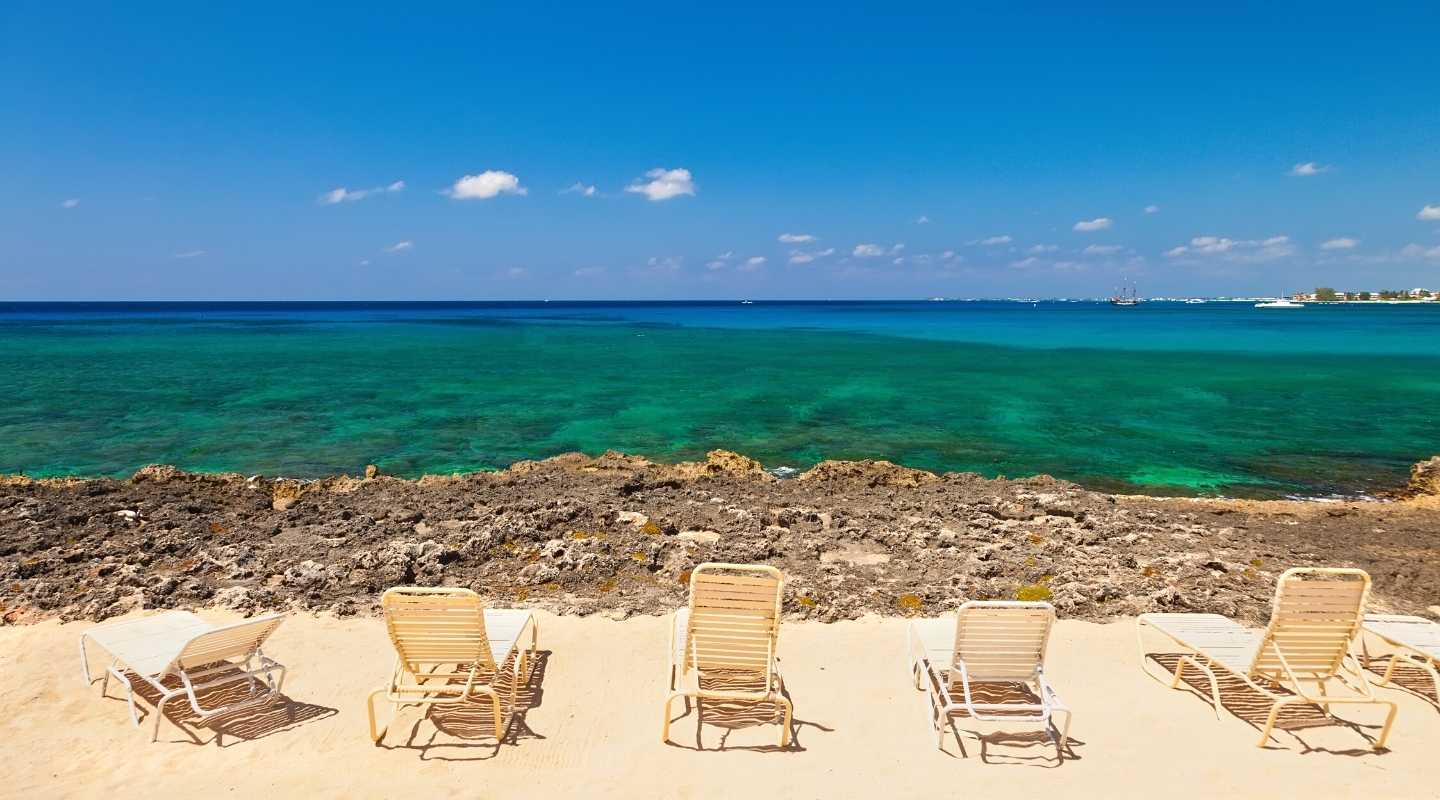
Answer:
[{"left": 1250, "top": 567, "right": 1369, "bottom": 679}]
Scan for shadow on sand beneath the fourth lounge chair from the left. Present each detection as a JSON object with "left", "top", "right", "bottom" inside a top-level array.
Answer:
[{"left": 942, "top": 682, "right": 1084, "bottom": 770}]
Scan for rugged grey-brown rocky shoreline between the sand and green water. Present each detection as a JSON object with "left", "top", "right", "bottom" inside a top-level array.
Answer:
[{"left": 0, "top": 450, "right": 1440, "bottom": 624}]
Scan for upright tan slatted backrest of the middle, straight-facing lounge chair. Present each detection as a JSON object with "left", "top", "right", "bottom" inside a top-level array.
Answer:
[{"left": 685, "top": 563, "right": 785, "bottom": 682}]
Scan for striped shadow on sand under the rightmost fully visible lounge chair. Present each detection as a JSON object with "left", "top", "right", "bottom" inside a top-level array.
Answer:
[{"left": 1145, "top": 653, "right": 1398, "bottom": 755}]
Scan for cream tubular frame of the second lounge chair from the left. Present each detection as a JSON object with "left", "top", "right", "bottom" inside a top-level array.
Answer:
[{"left": 366, "top": 586, "right": 540, "bottom": 744}]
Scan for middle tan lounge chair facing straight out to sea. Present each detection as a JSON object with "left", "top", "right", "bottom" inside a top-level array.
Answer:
[{"left": 661, "top": 564, "right": 792, "bottom": 747}]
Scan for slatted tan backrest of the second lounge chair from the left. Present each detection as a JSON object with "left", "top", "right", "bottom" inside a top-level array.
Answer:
[{"left": 380, "top": 586, "right": 495, "bottom": 673}]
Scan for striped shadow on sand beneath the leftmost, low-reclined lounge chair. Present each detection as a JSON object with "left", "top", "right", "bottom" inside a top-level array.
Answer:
[{"left": 115, "top": 664, "right": 338, "bottom": 747}]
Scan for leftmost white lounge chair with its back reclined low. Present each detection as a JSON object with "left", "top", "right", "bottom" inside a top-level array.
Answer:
[{"left": 81, "top": 612, "right": 285, "bottom": 741}]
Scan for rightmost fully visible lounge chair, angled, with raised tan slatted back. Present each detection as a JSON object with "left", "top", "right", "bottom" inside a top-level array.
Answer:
[{"left": 1136, "top": 568, "right": 1397, "bottom": 750}]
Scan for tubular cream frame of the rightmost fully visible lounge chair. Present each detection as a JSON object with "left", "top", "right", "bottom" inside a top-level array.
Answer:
[{"left": 1135, "top": 567, "right": 1398, "bottom": 750}]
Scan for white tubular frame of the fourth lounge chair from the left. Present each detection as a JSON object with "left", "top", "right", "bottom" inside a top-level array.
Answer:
[{"left": 906, "top": 600, "right": 1074, "bottom": 754}]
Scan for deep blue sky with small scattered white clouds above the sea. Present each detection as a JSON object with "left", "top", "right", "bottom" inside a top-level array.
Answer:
[{"left": 0, "top": 1, "right": 1440, "bottom": 299}]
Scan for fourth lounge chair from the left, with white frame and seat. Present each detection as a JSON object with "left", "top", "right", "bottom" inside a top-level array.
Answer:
[{"left": 907, "top": 600, "right": 1070, "bottom": 753}]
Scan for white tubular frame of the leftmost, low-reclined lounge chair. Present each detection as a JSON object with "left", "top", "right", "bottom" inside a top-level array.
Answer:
[{"left": 79, "top": 614, "right": 285, "bottom": 741}]
